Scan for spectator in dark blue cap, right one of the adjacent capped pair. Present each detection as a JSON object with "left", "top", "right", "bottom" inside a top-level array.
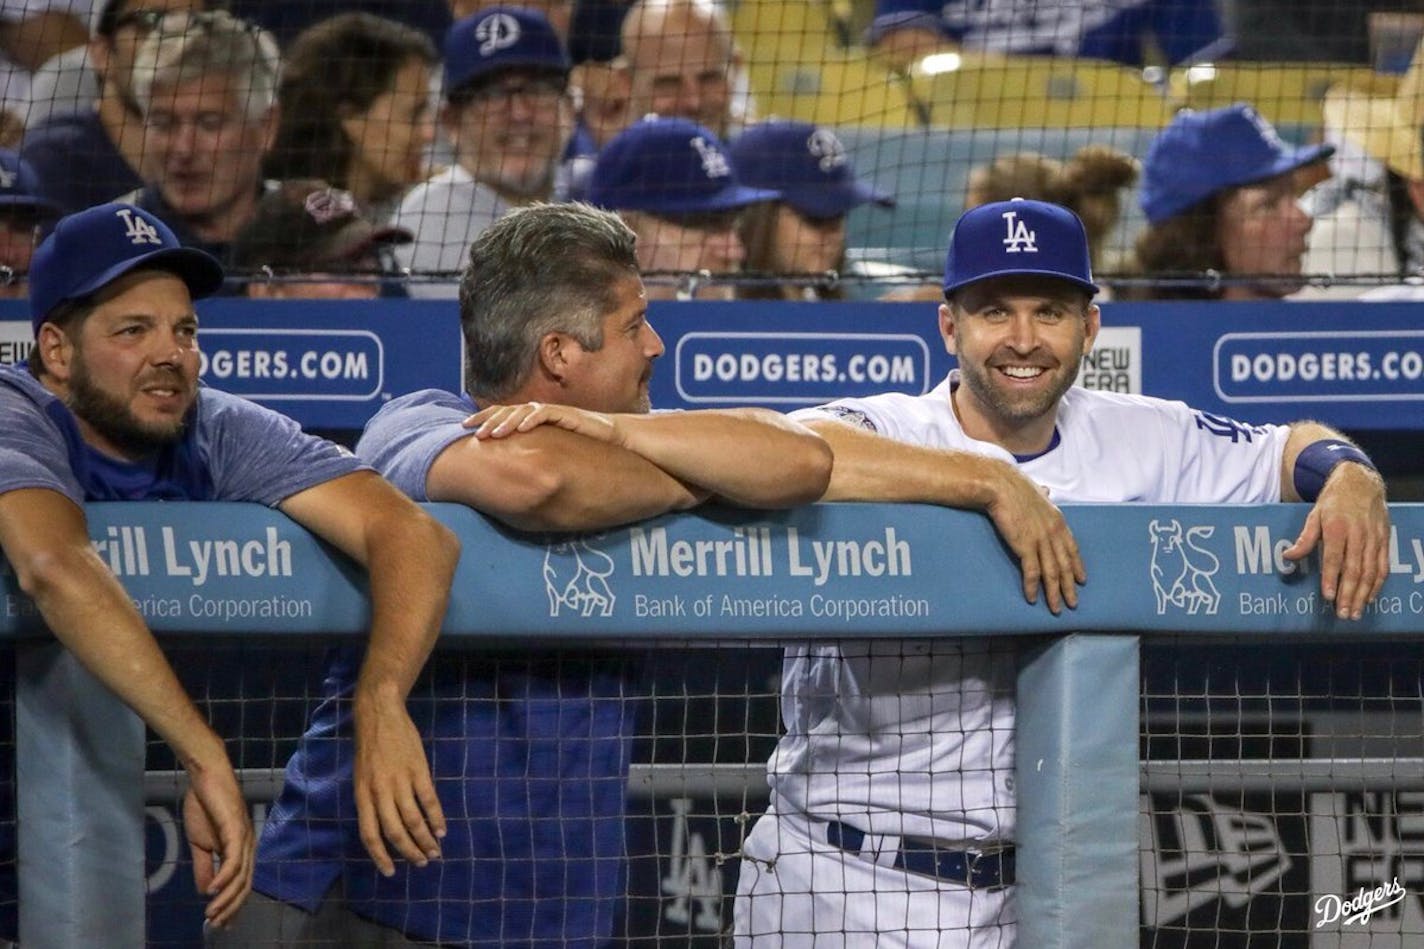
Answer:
[{"left": 729, "top": 121, "right": 894, "bottom": 301}]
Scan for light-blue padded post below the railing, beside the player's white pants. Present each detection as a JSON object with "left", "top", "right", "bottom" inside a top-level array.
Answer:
[{"left": 1015, "top": 633, "right": 1139, "bottom": 949}]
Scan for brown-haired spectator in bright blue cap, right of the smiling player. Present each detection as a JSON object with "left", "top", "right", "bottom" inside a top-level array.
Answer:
[{"left": 1134, "top": 103, "right": 1334, "bottom": 299}]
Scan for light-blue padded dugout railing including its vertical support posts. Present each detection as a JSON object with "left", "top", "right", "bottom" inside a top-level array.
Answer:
[{"left": 11, "top": 504, "right": 1424, "bottom": 949}]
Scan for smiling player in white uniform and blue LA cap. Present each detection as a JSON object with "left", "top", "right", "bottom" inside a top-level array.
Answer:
[{"left": 735, "top": 199, "right": 1388, "bottom": 949}]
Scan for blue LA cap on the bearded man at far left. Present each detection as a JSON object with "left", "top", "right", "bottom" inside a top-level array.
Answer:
[{"left": 30, "top": 204, "right": 224, "bottom": 332}]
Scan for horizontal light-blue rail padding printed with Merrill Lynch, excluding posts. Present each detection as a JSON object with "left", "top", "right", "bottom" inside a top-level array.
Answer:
[{"left": 0, "top": 503, "right": 1424, "bottom": 638}]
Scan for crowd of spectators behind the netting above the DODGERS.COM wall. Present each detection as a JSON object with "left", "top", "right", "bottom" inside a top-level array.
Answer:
[{"left": 0, "top": 0, "right": 1424, "bottom": 299}]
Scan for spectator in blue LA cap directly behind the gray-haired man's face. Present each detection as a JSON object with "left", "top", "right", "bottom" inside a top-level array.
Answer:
[{"left": 588, "top": 117, "right": 780, "bottom": 299}]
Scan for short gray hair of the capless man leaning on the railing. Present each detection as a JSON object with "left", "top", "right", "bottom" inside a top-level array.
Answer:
[{"left": 460, "top": 202, "right": 638, "bottom": 402}]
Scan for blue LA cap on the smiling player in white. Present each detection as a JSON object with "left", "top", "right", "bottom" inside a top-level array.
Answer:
[{"left": 944, "top": 198, "right": 1098, "bottom": 296}]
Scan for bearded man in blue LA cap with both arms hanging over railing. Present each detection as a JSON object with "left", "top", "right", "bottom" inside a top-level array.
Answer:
[{"left": 0, "top": 204, "right": 457, "bottom": 925}]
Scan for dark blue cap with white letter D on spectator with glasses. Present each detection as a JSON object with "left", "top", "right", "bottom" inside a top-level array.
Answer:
[{"left": 444, "top": 7, "right": 571, "bottom": 98}]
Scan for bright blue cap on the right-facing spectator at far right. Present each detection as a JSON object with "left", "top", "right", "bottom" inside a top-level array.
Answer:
[{"left": 1139, "top": 103, "right": 1334, "bottom": 224}]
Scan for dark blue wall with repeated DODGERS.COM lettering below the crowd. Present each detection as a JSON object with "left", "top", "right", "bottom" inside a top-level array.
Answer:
[{"left": 0, "top": 299, "right": 1424, "bottom": 430}]
